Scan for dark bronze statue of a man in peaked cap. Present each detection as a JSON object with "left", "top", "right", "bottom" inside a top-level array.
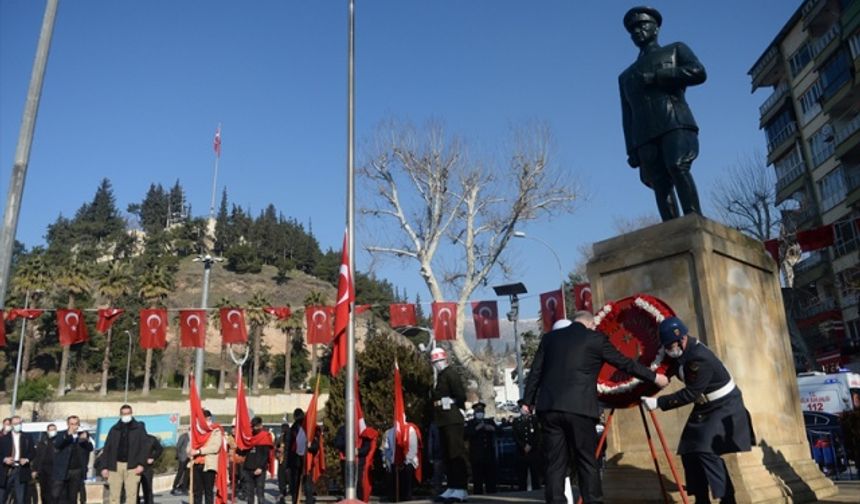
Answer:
[{"left": 618, "top": 7, "right": 706, "bottom": 222}]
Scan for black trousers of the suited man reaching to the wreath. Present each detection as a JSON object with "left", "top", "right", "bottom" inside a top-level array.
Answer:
[{"left": 539, "top": 411, "right": 603, "bottom": 504}]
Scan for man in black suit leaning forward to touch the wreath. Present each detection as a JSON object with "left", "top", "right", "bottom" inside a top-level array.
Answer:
[{"left": 524, "top": 312, "right": 669, "bottom": 504}]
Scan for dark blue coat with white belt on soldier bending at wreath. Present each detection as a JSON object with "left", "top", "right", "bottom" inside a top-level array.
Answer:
[{"left": 657, "top": 337, "right": 755, "bottom": 455}]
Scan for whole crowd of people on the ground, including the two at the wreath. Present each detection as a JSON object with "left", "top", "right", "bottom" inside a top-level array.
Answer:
[{"left": 0, "top": 312, "right": 755, "bottom": 504}]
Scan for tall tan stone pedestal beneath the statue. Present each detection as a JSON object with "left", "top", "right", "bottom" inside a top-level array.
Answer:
[{"left": 588, "top": 215, "right": 837, "bottom": 503}]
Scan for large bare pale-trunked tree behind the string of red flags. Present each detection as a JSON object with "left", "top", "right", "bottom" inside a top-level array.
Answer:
[{"left": 360, "top": 121, "right": 579, "bottom": 407}]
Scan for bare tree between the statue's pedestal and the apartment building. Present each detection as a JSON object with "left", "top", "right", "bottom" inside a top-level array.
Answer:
[{"left": 711, "top": 152, "right": 780, "bottom": 241}]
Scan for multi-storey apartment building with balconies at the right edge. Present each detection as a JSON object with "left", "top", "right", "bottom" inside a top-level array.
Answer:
[{"left": 749, "top": 0, "right": 860, "bottom": 368}]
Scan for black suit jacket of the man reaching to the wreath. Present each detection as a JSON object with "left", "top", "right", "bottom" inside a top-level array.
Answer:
[{"left": 525, "top": 322, "right": 656, "bottom": 418}]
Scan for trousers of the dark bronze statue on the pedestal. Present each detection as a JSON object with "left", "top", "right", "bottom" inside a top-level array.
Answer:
[{"left": 637, "top": 129, "right": 702, "bottom": 221}]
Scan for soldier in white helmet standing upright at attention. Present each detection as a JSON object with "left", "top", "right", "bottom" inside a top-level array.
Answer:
[{"left": 430, "top": 348, "right": 468, "bottom": 502}]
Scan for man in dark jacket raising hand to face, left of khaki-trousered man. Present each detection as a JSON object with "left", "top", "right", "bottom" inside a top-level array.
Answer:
[{"left": 51, "top": 415, "right": 93, "bottom": 504}]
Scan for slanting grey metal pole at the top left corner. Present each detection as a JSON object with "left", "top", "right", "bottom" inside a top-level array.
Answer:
[{"left": 0, "top": 0, "right": 59, "bottom": 308}]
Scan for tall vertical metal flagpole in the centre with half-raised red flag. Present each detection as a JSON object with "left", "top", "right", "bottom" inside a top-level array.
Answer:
[{"left": 344, "top": 0, "right": 357, "bottom": 500}]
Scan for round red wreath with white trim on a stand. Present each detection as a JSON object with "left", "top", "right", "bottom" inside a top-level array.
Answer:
[{"left": 596, "top": 294, "right": 675, "bottom": 408}]
